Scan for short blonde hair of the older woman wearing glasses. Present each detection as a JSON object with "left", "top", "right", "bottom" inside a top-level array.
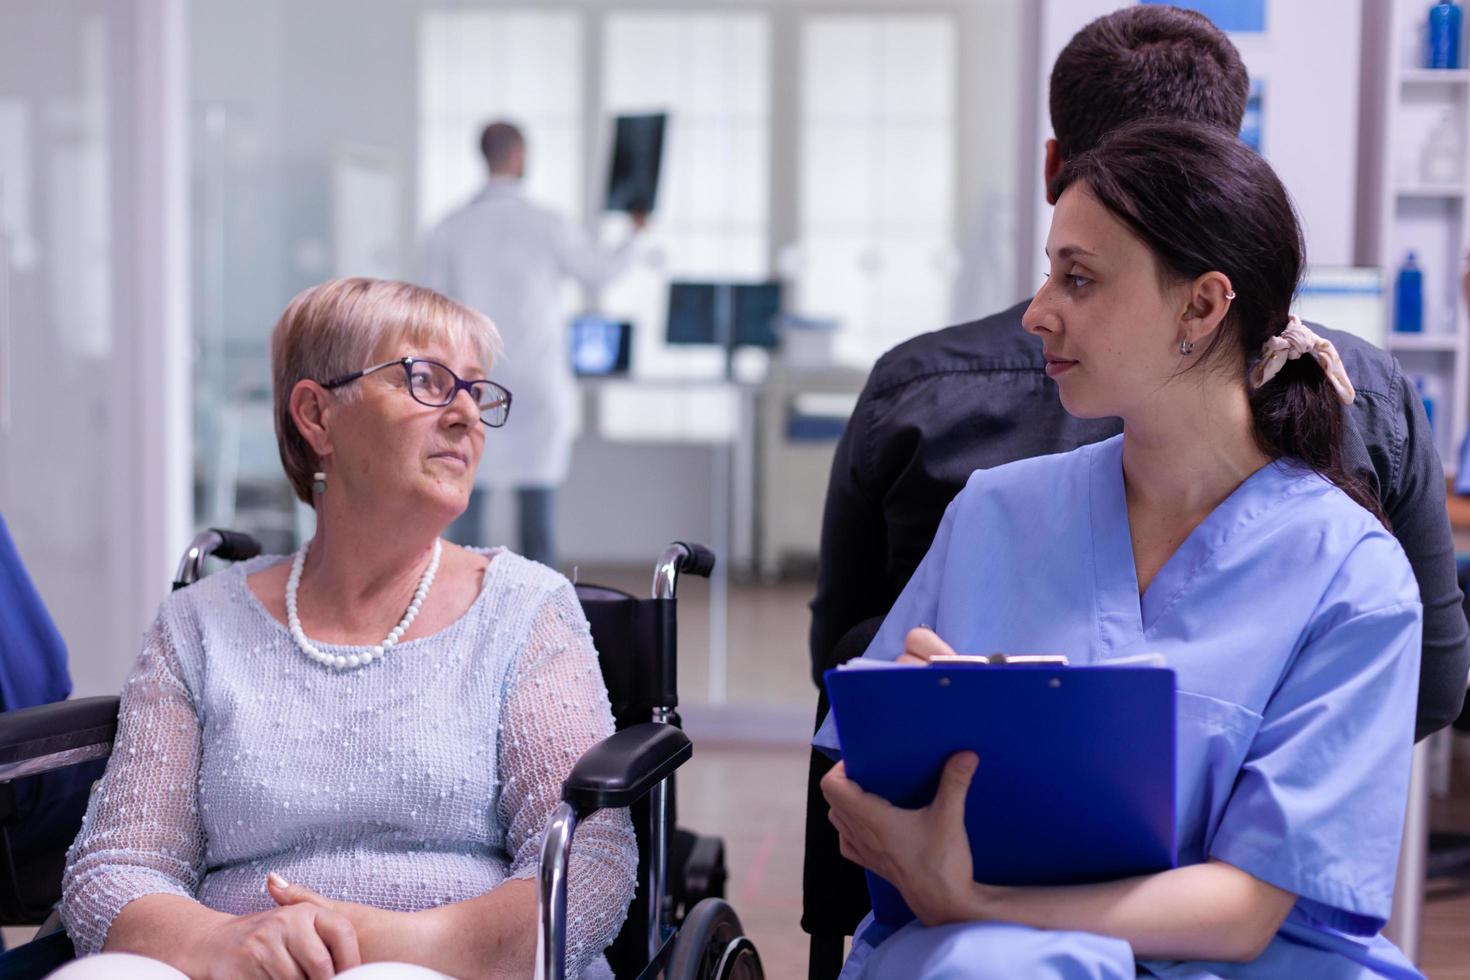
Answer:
[{"left": 270, "top": 276, "right": 501, "bottom": 504}]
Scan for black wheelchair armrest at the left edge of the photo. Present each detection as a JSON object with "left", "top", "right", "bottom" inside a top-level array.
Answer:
[{"left": 0, "top": 698, "right": 119, "bottom": 782}]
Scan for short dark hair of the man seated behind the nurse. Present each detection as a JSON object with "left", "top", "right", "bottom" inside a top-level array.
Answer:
[{"left": 1051, "top": 4, "right": 1251, "bottom": 159}]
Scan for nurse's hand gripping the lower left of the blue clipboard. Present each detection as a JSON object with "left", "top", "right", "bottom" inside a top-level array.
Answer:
[{"left": 822, "top": 752, "right": 979, "bottom": 926}]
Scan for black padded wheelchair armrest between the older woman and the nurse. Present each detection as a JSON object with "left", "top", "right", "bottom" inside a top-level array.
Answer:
[{"left": 562, "top": 721, "right": 694, "bottom": 818}]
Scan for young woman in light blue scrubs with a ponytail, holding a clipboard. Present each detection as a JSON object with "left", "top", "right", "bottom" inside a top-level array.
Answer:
[{"left": 816, "top": 122, "right": 1421, "bottom": 979}]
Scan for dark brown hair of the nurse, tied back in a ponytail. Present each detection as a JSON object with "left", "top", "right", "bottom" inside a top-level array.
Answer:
[{"left": 1050, "top": 119, "right": 1388, "bottom": 526}]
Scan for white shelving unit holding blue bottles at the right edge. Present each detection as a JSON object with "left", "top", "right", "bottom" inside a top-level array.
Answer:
[{"left": 1357, "top": 0, "right": 1470, "bottom": 473}]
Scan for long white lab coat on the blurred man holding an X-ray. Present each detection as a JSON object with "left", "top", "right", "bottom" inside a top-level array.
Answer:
[{"left": 426, "top": 178, "right": 632, "bottom": 488}]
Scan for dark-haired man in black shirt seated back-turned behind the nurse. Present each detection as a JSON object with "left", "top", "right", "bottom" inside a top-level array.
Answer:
[{"left": 801, "top": 6, "right": 1470, "bottom": 976}]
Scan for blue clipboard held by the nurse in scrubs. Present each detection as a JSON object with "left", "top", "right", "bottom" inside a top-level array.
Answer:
[{"left": 826, "top": 664, "right": 1176, "bottom": 927}]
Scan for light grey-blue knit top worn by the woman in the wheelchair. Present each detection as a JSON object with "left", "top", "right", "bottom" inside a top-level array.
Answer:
[{"left": 62, "top": 551, "right": 638, "bottom": 976}]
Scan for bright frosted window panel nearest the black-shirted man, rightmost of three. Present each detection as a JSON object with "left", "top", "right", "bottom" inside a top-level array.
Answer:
[{"left": 798, "top": 15, "right": 956, "bottom": 364}]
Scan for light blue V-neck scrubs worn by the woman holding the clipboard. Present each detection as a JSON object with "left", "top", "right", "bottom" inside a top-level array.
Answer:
[{"left": 813, "top": 436, "right": 1421, "bottom": 977}]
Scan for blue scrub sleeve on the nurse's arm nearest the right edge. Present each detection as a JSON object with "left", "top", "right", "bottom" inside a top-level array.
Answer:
[{"left": 1210, "top": 587, "right": 1421, "bottom": 936}]
